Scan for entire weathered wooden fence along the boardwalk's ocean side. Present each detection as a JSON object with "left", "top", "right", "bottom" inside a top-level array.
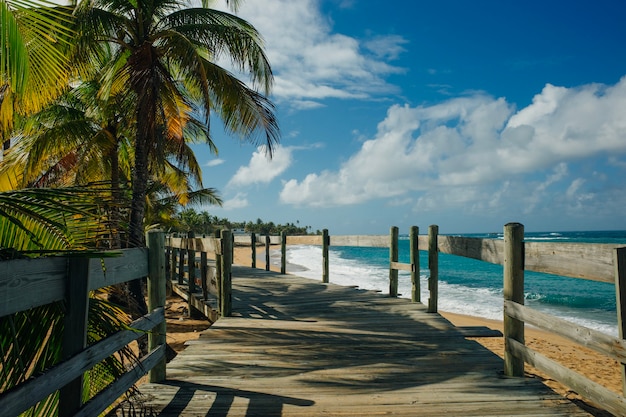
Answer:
[{"left": 236, "top": 223, "right": 626, "bottom": 416}]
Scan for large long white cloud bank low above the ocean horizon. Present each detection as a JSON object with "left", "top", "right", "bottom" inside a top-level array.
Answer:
[{"left": 280, "top": 78, "right": 626, "bottom": 210}]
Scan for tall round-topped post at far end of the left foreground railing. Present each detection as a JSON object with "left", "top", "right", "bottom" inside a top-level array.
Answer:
[{"left": 146, "top": 230, "right": 166, "bottom": 382}]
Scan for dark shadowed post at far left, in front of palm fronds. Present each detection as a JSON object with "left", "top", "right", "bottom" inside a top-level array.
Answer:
[{"left": 59, "top": 257, "right": 89, "bottom": 417}]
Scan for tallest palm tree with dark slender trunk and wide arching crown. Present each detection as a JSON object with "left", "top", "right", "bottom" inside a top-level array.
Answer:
[{"left": 76, "top": 0, "right": 279, "bottom": 246}]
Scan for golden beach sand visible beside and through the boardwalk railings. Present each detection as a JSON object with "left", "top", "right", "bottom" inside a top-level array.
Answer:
[{"left": 157, "top": 247, "right": 622, "bottom": 416}]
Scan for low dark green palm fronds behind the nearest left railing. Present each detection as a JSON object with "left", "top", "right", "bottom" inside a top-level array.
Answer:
[{"left": 0, "top": 185, "right": 136, "bottom": 416}]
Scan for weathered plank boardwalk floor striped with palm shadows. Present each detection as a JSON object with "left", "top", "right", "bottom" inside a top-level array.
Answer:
[{"left": 132, "top": 267, "right": 589, "bottom": 417}]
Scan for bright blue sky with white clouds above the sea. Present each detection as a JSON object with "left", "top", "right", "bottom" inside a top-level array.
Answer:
[{"left": 194, "top": 0, "right": 626, "bottom": 235}]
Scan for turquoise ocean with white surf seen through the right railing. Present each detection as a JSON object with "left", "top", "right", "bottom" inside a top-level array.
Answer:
[{"left": 272, "top": 231, "right": 626, "bottom": 336}]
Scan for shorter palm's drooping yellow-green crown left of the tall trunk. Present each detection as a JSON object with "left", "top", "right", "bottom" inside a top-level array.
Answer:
[{"left": 0, "top": 82, "right": 130, "bottom": 184}]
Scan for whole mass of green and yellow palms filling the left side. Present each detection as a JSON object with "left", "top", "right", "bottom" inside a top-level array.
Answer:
[{"left": 0, "top": 0, "right": 279, "bottom": 415}]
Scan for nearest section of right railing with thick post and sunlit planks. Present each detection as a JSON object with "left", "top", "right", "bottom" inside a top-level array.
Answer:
[{"left": 428, "top": 223, "right": 626, "bottom": 416}]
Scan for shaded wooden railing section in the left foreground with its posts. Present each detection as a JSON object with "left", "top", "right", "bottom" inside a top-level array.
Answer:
[{"left": 0, "top": 232, "right": 165, "bottom": 416}]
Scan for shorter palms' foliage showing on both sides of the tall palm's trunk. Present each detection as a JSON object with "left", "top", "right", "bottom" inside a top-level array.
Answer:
[{"left": 0, "top": 72, "right": 221, "bottom": 244}]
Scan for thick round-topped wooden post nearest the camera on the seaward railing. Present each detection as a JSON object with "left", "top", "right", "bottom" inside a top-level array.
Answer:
[{"left": 504, "top": 223, "right": 524, "bottom": 377}]
